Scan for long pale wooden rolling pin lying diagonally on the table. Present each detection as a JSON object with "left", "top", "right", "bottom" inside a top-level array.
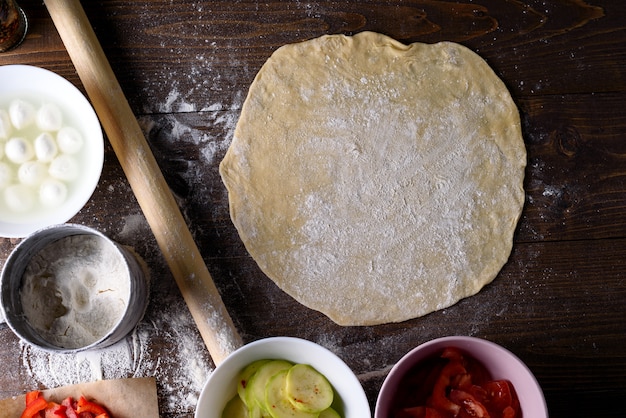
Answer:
[{"left": 44, "top": 0, "right": 242, "bottom": 365}]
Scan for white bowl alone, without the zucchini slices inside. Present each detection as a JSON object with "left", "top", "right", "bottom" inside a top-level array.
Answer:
[{"left": 195, "top": 337, "right": 372, "bottom": 418}]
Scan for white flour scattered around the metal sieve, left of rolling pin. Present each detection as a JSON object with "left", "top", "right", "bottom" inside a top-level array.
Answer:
[{"left": 19, "top": 213, "right": 213, "bottom": 417}]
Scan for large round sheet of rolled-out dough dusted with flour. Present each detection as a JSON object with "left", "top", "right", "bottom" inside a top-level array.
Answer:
[{"left": 220, "top": 32, "right": 526, "bottom": 325}]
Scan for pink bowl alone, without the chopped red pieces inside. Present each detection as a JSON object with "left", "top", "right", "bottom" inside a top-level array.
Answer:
[{"left": 374, "top": 336, "right": 548, "bottom": 418}]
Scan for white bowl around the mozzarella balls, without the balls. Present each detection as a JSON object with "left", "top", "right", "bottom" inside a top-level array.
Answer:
[{"left": 0, "top": 65, "right": 104, "bottom": 238}]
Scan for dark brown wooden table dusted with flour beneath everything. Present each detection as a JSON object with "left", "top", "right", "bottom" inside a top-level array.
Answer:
[{"left": 0, "top": 0, "right": 626, "bottom": 418}]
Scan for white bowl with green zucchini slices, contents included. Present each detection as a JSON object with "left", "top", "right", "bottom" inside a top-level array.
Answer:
[{"left": 195, "top": 337, "right": 371, "bottom": 418}]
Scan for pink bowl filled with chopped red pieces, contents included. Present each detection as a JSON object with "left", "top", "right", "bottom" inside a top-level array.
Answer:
[{"left": 374, "top": 336, "right": 548, "bottom": 418}]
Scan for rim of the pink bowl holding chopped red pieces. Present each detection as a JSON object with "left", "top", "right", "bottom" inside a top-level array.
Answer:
[{"left": 374, "top": 335, "right": 548, "bottom": 418}]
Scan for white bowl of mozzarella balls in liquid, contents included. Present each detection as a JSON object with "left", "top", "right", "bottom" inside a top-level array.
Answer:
[{"left": 0, "top": 65, "right": 104, "bottom": 238}]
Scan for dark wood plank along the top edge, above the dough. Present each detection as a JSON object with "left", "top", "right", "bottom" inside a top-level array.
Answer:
[{"left": 3, "top": 0, "right": 626, "bottom": 107}]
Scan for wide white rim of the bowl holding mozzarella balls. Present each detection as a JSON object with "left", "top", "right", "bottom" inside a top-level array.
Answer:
[{"left": 0, "top": 64, "right": 104, "bottom": 238}]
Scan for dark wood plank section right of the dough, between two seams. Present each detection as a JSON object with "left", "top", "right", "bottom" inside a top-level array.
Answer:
[{"left": 517, "top": 93, "right": 626, "bottom": 241}]
